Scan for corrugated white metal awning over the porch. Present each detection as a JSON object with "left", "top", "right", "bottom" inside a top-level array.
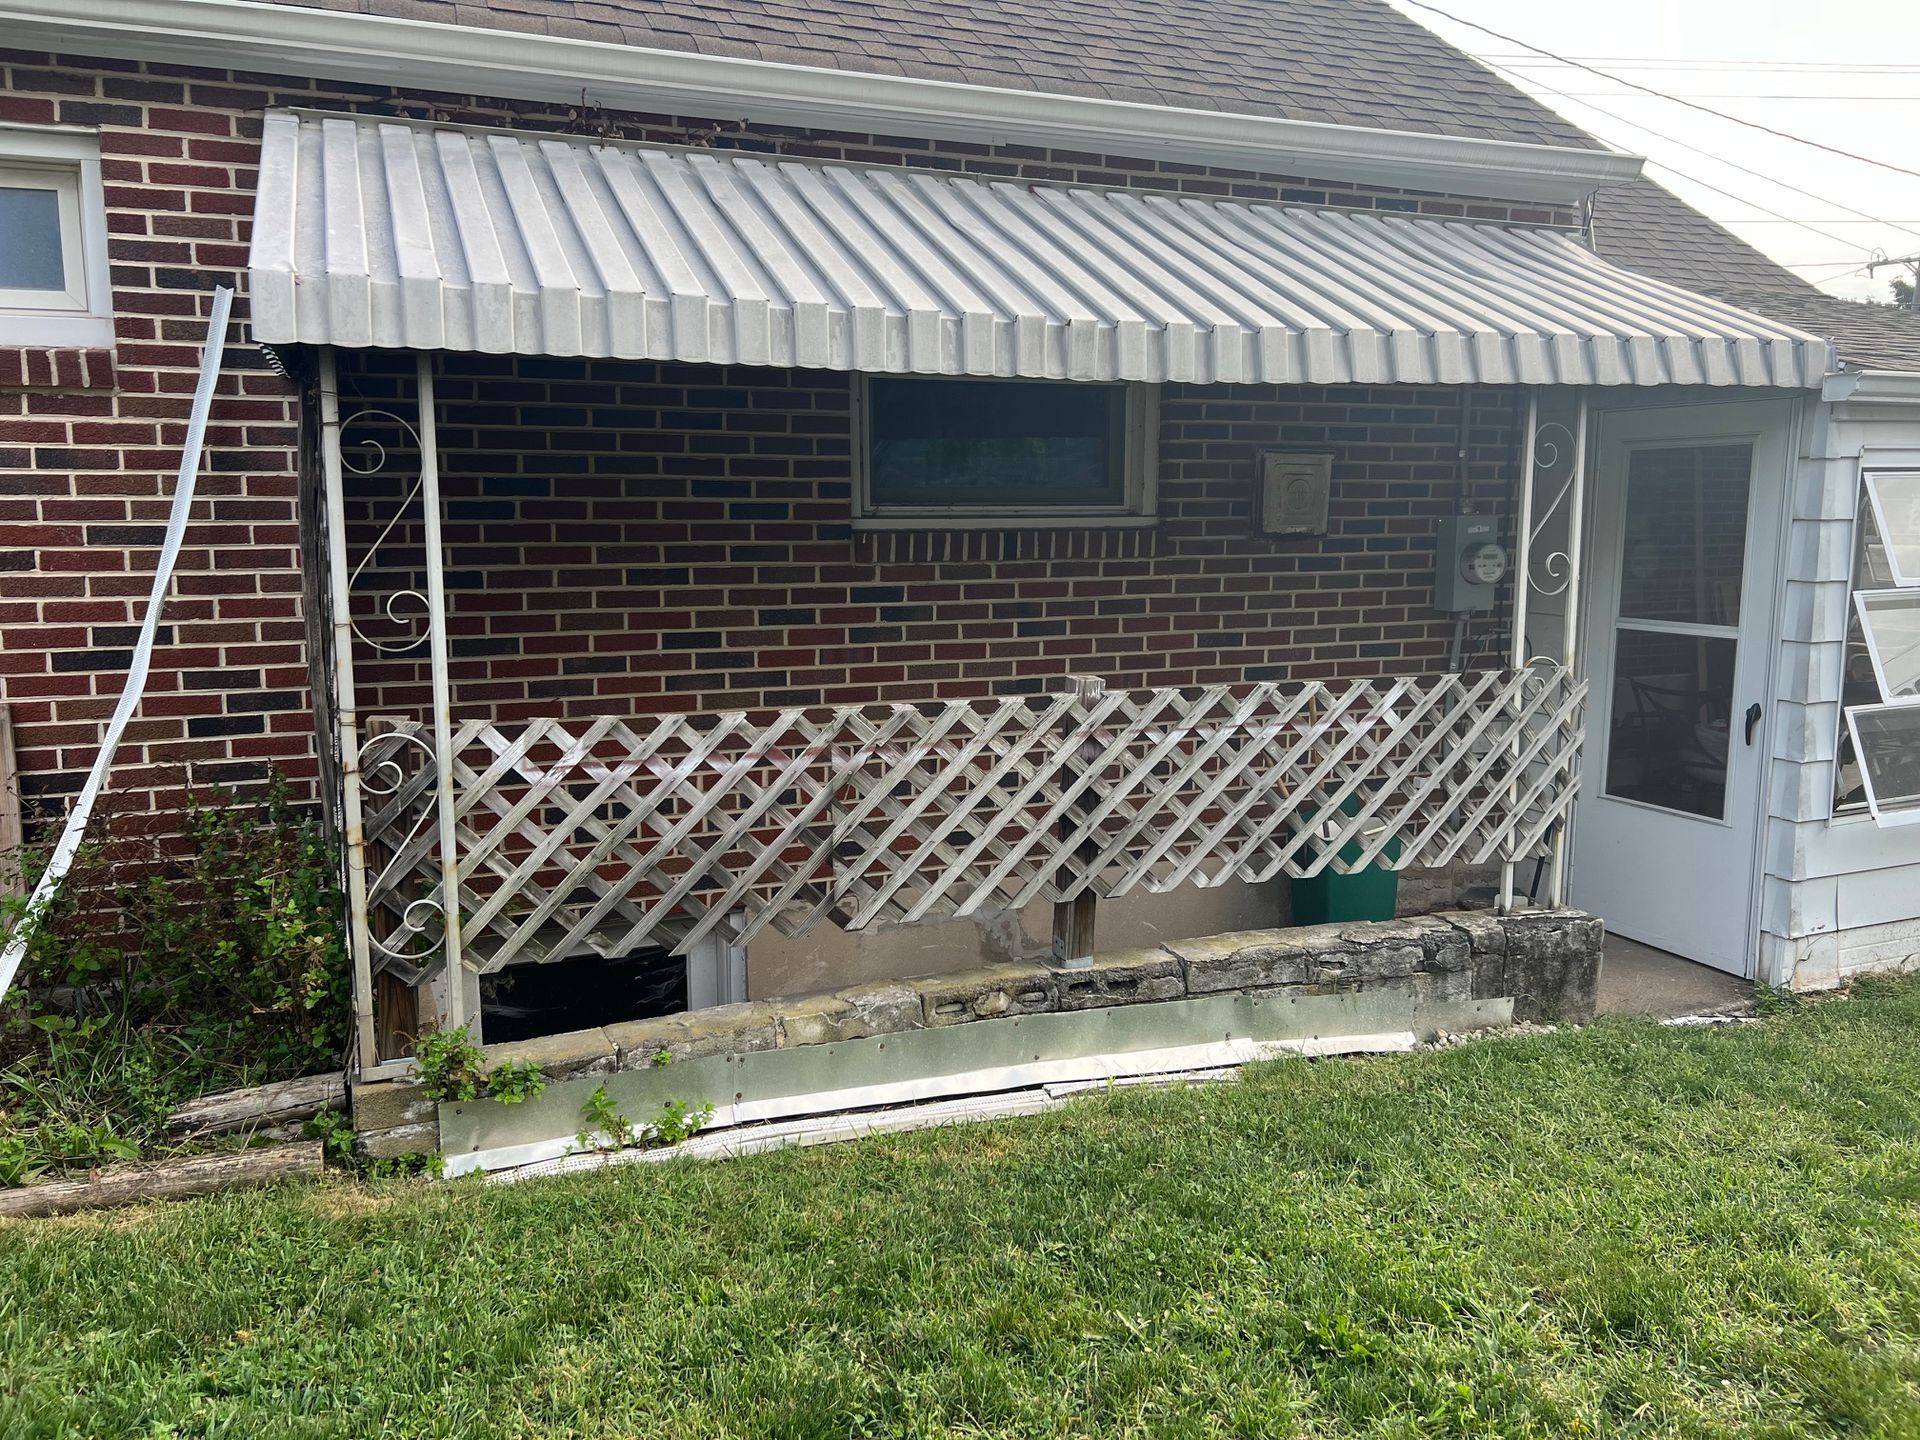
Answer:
[{"left": 252, "top": 111, "right": 1828, "bottom": 388}]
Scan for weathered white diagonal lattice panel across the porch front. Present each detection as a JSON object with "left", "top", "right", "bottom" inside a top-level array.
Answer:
[{"left": 353, "top": 666, "right": 1584, "bottom": 970}]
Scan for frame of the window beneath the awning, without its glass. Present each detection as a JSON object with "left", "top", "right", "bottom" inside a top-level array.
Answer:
[{"left": 849, "top": 374, "right": 1160, "bottom": 530}]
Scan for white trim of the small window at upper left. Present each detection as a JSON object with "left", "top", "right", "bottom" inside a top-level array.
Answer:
[{"left": 0, "top": 125, "right": 113, "bottom": 349}]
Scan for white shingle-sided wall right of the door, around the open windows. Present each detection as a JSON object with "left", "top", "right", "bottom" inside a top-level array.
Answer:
[{"left": 1759, "top": 384, "right": 1920, "bottom": 989}]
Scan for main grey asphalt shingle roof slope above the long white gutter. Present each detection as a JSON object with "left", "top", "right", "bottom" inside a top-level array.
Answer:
[{"left": 273, "top": 0, "right": 1594, "bottom": 146}]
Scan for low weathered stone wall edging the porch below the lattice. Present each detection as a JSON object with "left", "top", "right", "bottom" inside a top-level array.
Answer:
[{"left": 353, "top": 910, "right": 1603, "bottom": 1158}]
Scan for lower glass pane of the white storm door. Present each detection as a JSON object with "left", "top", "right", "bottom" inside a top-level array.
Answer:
[{"left": 1607, "top": 626, "right": 1736, "bottom": 820}]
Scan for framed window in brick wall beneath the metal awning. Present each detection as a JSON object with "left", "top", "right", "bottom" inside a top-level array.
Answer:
[{"left": 854, "top": 374, "right": 1158, "bottom": 528}]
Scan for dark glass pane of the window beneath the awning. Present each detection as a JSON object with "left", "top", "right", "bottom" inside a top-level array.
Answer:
[{"left": 868, "top": 378, "right": 1127, "bottom": 507}]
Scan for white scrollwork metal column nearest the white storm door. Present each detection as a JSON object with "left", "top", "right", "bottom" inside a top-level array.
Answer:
[{"left": 1500, "top": 388, "right": 1588, "bottom": 910}]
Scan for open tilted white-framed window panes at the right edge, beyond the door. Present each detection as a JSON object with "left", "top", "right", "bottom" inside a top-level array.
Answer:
[{"left": 1834, "top": 470, "right": 1920, "bottom": 826}]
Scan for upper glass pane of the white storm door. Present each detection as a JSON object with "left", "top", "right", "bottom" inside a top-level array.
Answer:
[{"left": 1620, "top": 444, "right": 1753, "bottom": 626}]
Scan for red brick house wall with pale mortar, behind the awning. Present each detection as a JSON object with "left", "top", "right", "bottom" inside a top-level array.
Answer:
[{"left": 0, "top": 50, "right": 1572, "bottom": 808}]
